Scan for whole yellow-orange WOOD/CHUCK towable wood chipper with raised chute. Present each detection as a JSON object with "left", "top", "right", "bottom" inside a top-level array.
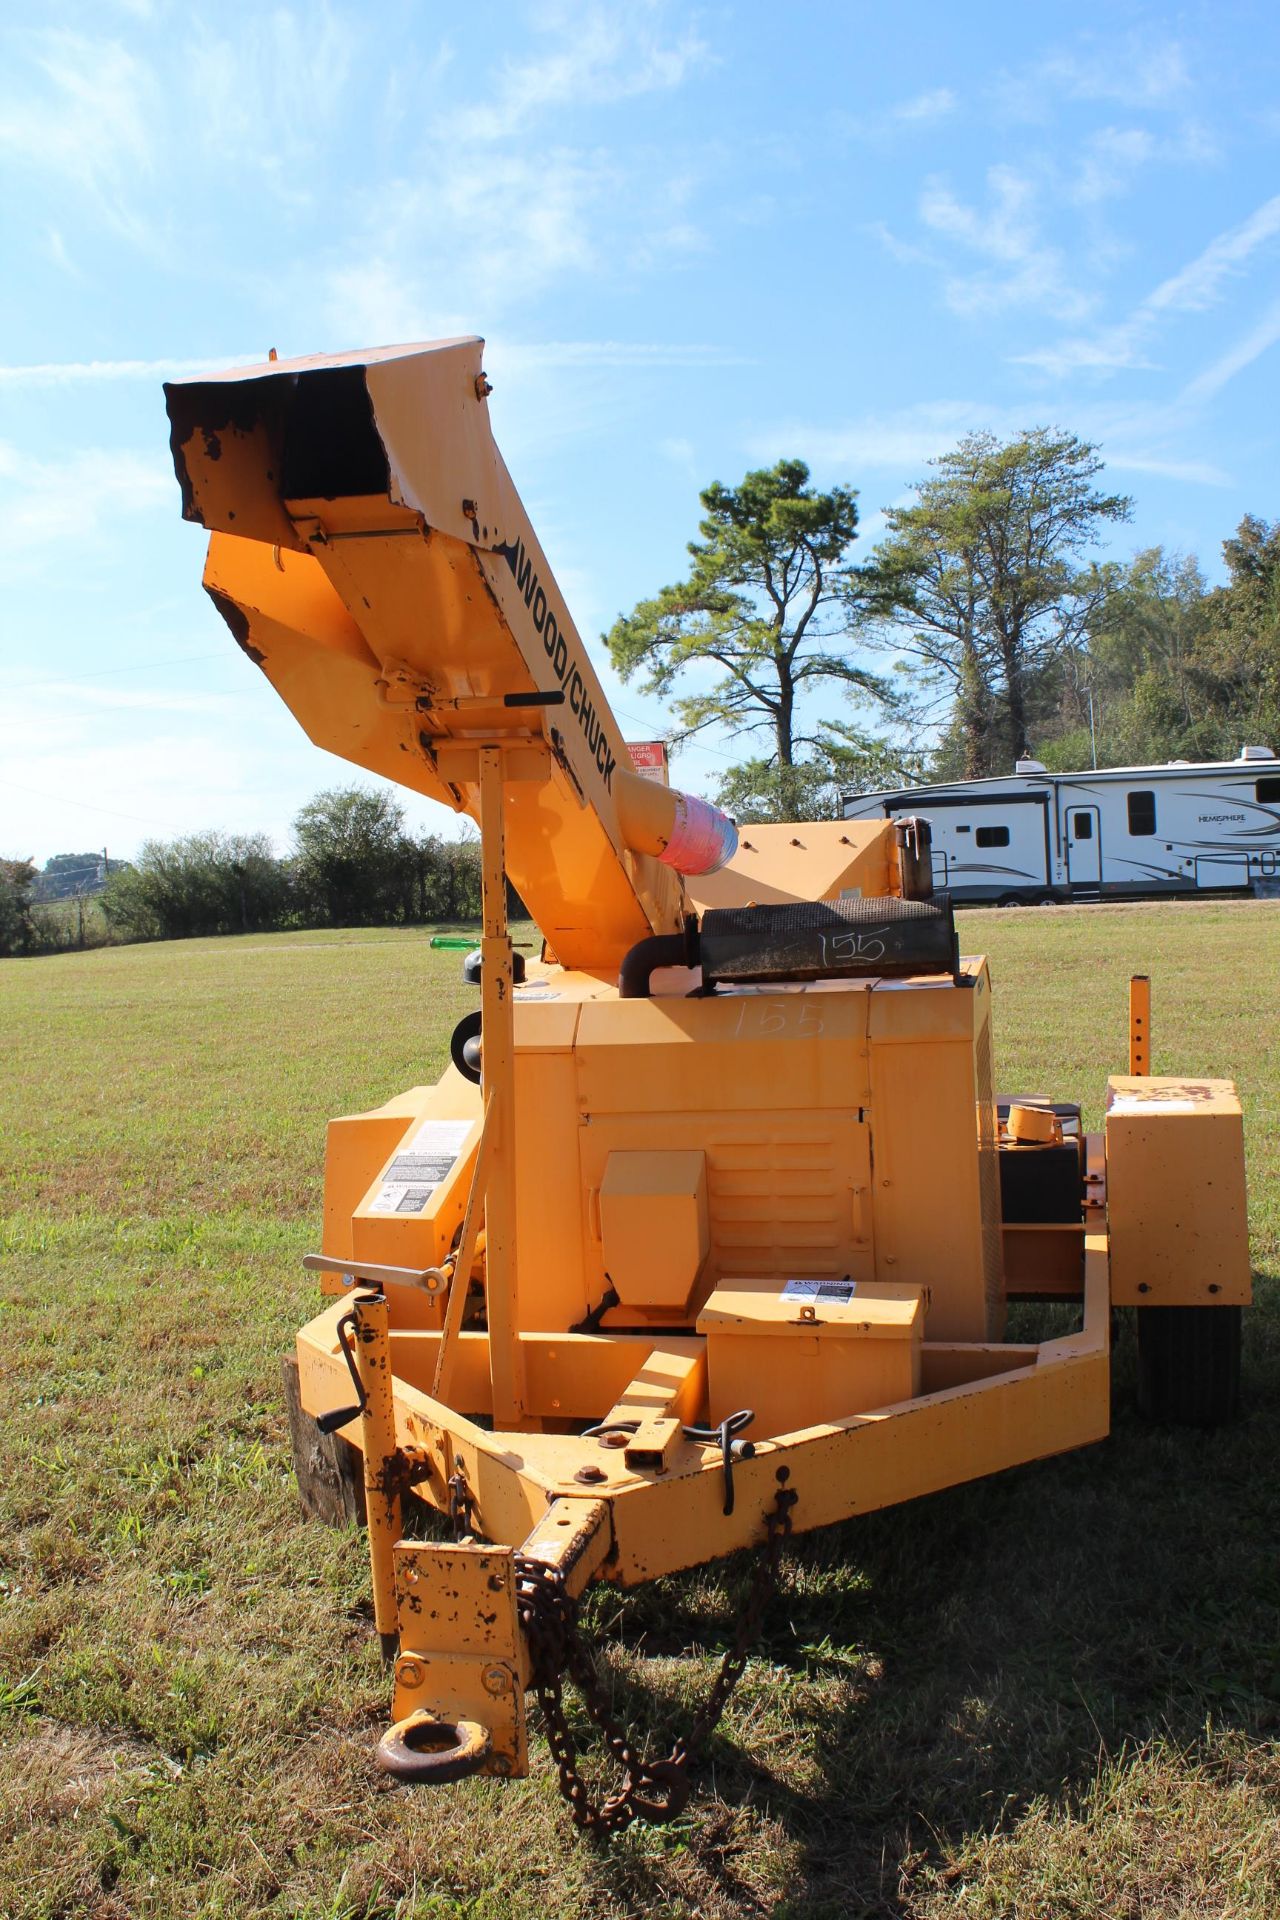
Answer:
[{"left": 167, "top": 340, "right": 1249, "bottom": 1828}]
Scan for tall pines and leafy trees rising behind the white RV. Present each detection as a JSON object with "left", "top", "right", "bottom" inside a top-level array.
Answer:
[{"left": 604, "top": 428, "right": 1280, "bottom": 820}]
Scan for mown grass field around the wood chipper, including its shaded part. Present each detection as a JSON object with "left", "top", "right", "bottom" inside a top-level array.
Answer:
[{"left": 0, "top": 904, "right": 1280, "bottom": 1920}]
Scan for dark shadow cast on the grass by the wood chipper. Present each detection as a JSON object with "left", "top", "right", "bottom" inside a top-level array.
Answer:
[{"left": 571, "top": 1279, "right": 1280, "bottom": 1920}]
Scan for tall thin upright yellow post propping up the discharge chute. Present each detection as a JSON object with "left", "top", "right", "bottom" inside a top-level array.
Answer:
[{"left": 477, "top": 747, "right": 524, "bottom": 1428}]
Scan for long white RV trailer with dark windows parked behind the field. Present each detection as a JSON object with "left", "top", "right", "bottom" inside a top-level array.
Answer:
[{"left": 844, "top": 747, "right": 1280, "bottom": 906}]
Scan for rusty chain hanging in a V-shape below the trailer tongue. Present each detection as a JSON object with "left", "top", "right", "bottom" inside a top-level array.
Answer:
[{"left": 516, "top": 1469, "right": 796, "bottom": 1834}]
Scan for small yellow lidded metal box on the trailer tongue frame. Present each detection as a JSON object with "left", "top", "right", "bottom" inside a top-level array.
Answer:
[{"left": 699, "top": 1277, "right": 927, "bottom": 1438}]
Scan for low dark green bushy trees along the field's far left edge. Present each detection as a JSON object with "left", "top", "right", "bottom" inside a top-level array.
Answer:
[{"left": 0, "top": 787, "right": 480, "bottom": 956}]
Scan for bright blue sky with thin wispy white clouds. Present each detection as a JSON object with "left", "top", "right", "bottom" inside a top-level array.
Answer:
[{"left": 0, "top": 0, "right": 1280, "bottom": 860}]
